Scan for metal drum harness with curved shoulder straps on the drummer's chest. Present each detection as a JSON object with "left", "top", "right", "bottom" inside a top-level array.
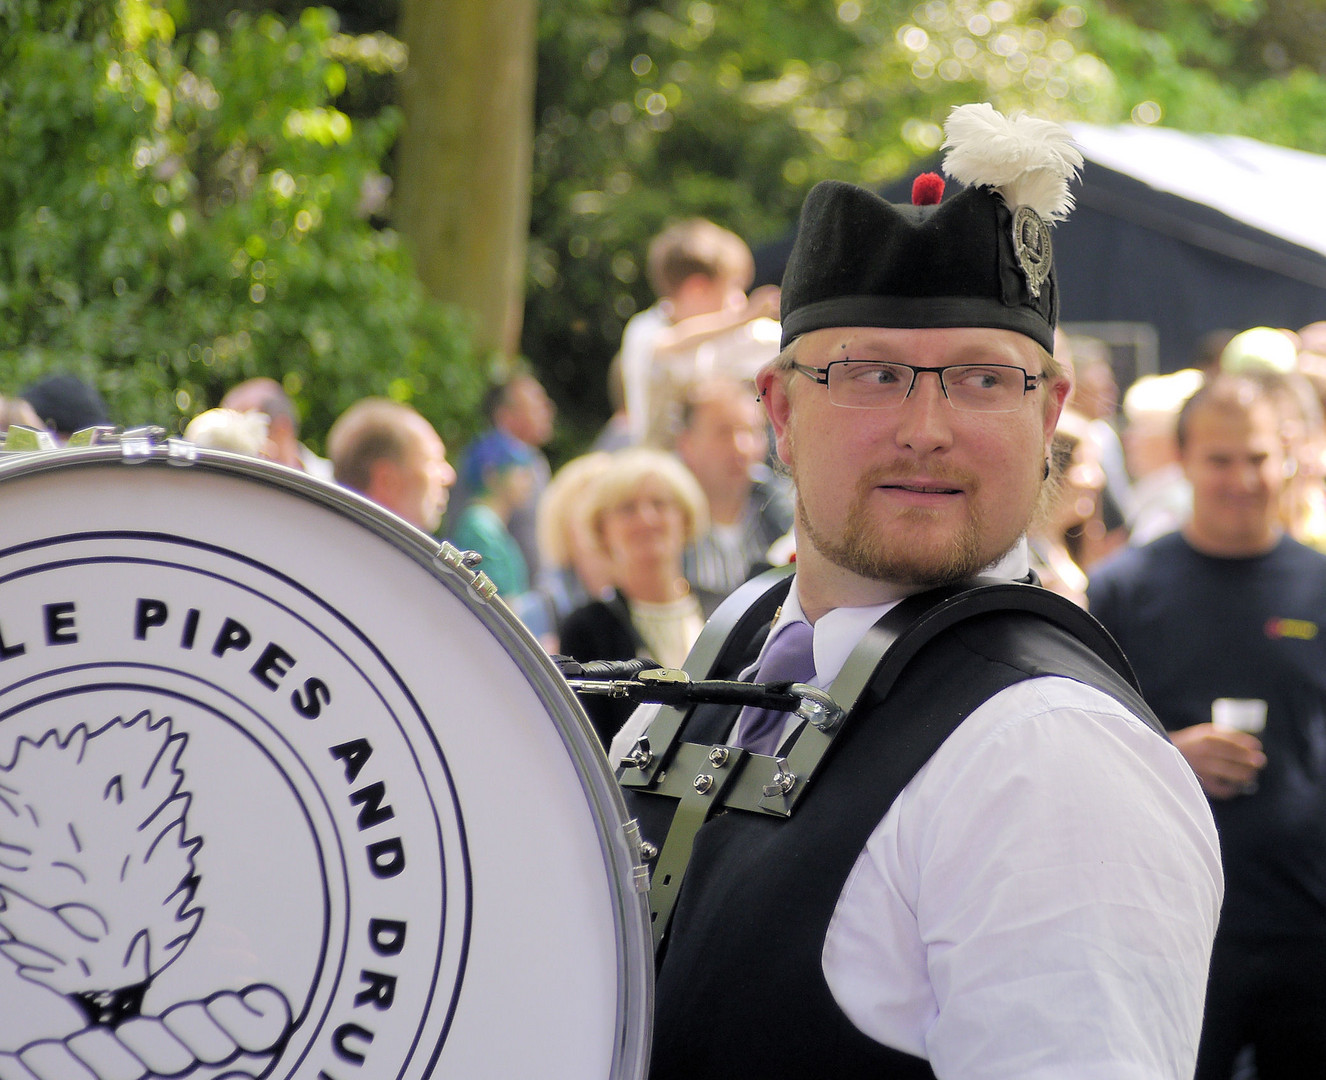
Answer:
[{"left": 561, "top": 567, "right": 1135, "bottom": 950}]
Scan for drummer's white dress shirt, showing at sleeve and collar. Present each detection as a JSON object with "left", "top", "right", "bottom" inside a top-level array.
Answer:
[{"left": 611, "top": 545, "right": 1224, "bottom": 1080}]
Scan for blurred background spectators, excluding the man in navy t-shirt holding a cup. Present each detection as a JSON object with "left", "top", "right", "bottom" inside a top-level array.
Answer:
[{"left": 0, "top": 219, "right": 1326, "bottom": 758}]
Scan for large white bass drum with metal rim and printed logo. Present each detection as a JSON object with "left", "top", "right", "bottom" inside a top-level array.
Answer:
[{"left": 0, "top": 443, "right": 652, "bottom": 1080}]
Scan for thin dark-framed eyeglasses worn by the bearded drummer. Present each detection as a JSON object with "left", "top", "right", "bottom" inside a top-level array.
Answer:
[{"left": 792, "top": 360, "right": 1045, "bottom": 413}]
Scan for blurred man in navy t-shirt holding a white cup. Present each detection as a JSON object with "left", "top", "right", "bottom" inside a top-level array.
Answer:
[{"left": 1087, "top": 375, "right": 1326, "bottom": 1080}]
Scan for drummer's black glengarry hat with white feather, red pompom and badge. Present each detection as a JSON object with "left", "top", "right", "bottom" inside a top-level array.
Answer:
[{"left": 781, "top": 105, "right": 1082, "bottom": 352}]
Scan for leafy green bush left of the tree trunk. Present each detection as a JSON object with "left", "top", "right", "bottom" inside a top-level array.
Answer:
[{"left": 0, "top": 0, "right": 483, "bottom": 444}]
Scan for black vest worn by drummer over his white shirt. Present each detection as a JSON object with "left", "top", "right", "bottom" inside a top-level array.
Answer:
[{"left": 627, "top": 612, "right": 1159, "bottom": 1080}]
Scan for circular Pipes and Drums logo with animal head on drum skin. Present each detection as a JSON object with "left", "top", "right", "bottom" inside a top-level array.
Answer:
[{"left": 0, "top": 533, "right": 471, "bottom": 1080}]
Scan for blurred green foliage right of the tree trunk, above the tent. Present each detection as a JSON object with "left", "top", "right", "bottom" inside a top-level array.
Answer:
[{"left": 524, "top": 0, "right": 1326, "bottom": 443}]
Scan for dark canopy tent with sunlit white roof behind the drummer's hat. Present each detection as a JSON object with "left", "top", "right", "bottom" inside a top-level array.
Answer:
[{"left": 756, "top": 125, "right": 1326, "bottom": 382}]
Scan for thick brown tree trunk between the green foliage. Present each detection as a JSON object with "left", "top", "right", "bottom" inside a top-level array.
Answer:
[{"left": 395, "top": 0, "right": 538, "bottom": 356}]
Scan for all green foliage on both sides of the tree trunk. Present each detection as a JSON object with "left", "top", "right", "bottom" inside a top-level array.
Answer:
[{"left": 10, "top": 0, "right": 1326, "bottom": 451}]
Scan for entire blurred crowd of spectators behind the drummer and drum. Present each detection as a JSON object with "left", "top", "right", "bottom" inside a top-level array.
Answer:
[{"left": 0, "top": 213, "right": 1326, "bottom": 1080}]
